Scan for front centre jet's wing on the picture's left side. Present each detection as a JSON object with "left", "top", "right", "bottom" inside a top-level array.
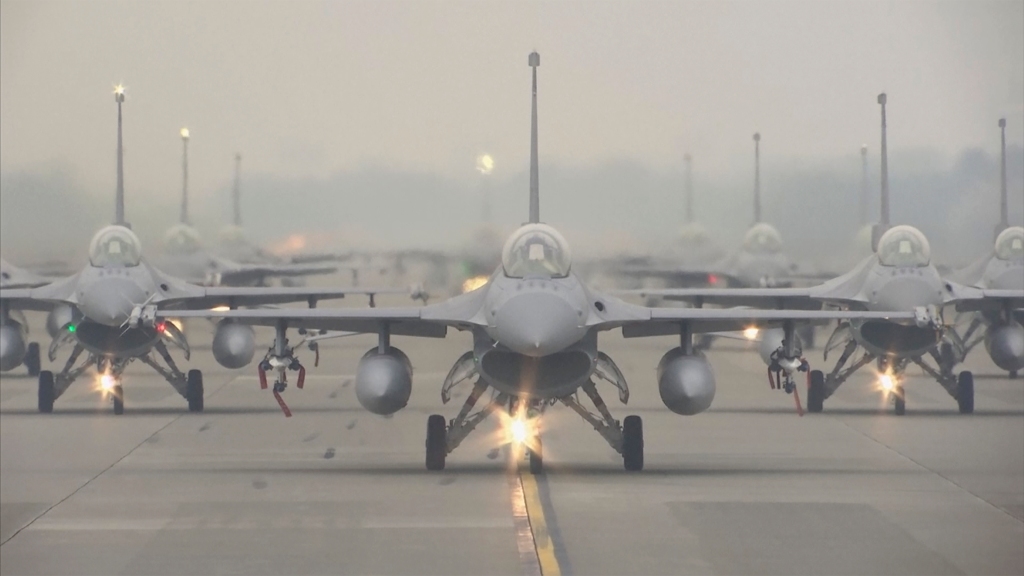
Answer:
[{"left": 149, "top": 282, "right": 486, "bottom": 338}]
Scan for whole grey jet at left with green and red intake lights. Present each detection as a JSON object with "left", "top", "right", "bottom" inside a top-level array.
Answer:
[{"left": 0, "top": 86, "right": 405, "bottom": 414}]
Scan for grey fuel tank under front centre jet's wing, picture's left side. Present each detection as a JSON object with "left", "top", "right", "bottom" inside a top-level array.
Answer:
[{"left": 355, "top": 346, "right": 413, "bottom": 416}]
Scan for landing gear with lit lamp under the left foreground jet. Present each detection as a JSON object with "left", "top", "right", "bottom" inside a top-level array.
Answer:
[{"left": 39, "top": 340, "right": 204, "bottom": 415}]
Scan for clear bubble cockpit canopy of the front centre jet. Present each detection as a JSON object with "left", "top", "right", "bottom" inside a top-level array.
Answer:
[{"left": 502, "top": 224, "right": 572, "bottom": 278}]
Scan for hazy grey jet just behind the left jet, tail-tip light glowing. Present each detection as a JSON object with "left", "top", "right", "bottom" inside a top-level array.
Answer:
[{"left": 153, "top": 128, "right": 338, "bottom": 286}]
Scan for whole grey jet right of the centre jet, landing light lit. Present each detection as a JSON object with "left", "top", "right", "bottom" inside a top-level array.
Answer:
[{"left": 622, "top": 94, "right": 1024, "bottom": 414}]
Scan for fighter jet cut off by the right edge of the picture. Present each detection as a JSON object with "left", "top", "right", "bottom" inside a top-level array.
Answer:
[{"left": 940, "top": 118, "right": 1024, "bottom": 378}]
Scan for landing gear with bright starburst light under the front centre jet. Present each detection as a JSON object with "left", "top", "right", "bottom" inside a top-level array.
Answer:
[{"left": 426, "top": 355, "right": 644, "bottom": 475}]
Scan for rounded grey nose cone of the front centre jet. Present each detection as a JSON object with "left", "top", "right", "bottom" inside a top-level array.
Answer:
[{"left": 492, "top": 292, "right": 587, "bottom": 357}]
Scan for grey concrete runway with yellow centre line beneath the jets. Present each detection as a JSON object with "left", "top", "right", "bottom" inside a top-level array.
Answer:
[{"left": 0, "top": 313, "right": 1024, "bottom": 575}]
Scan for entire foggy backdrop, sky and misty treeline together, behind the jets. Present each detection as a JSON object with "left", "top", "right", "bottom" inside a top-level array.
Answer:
[{"left": 0, "top": 0, "right": 1024, "bottom": 269}]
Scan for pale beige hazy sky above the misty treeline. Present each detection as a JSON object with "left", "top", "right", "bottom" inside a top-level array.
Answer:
[{"left": 0, "top": 0, "right": 1024, "bottom": 195}]
